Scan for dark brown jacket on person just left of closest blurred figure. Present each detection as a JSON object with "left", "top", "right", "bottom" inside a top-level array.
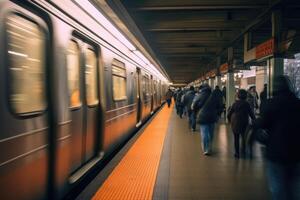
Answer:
[{"left": 227, "top": 100, "right": 255, "bottom": 134}]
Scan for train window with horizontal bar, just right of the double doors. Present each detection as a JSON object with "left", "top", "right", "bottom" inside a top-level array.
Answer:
[{"left": 112, "top": 59, "right": 127, "bottom": 101}]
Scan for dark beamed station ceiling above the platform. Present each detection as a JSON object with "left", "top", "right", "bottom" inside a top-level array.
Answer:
[{"left": 108, "top": 0, "right": 298, "bottom": 83}]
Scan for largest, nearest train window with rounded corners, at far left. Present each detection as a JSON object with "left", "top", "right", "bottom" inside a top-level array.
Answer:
[{"left": 6, "top": 15, "right": 46, "bottom": 114}]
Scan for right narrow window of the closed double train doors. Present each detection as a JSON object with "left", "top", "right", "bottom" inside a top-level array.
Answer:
[{"left": 85, "top": 48, "right": 98, "bottom": 106}]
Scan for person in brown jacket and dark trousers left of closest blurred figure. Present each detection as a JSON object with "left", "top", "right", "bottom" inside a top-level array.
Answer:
[{"left": 227, "top": 89, "right": 255, "bottom": 158}]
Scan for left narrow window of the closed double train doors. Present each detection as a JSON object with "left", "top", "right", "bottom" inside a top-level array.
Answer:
[{"left": 67, "top": 40, "right": 81, "bottom": 108}]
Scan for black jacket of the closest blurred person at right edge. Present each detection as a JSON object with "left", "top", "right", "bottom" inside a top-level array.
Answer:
[{"left": 256, "top": 92, "right": 300, "bottom": 163}]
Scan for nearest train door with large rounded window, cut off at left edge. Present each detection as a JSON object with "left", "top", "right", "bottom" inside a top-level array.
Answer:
[{"left": 0, "top": 8, "right": 49, "bottom": 199}]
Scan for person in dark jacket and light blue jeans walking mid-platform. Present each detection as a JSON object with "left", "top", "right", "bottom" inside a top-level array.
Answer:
[{"left": 195, "top": 86, "right": 222, "bottom": 155}]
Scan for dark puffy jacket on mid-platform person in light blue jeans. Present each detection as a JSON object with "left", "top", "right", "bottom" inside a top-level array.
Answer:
[{"left": 197, "top": 91, "right": 222, "bottom": 125}]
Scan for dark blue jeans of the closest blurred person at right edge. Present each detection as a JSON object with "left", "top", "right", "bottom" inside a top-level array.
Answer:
[{"left": 267, "top": 161, "right": 300, "bottom": 200}]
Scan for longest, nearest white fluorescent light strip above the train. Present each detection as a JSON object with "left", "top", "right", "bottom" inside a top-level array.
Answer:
[{"left": 75, "top": 0, "right": 136, "bottom": 51}]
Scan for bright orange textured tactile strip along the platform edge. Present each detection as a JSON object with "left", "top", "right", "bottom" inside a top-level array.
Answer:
[{"left": 93, "top": 105, "right": 173, "bottom": 200}]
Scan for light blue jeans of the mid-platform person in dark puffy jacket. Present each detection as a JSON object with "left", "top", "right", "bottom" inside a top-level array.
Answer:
[{"left": 200, "top": 123, "right": 215, "bottom": 152}]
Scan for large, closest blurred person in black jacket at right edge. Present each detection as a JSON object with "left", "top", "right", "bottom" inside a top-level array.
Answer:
[{"left": 256, "top": 76, "right": 300, "bottom": 200}]
